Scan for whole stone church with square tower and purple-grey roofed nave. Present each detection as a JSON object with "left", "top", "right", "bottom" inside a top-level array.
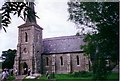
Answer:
[{"left": 14, "top": 2, "right": 89, "bottom": 74}]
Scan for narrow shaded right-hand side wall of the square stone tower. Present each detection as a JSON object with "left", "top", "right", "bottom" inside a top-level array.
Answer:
[{"left": 33, "top": 28, "right": 42, "bottom": 73}]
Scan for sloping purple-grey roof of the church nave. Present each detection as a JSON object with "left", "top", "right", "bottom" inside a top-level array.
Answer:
[{"left": 43, "top": 36, "right": 85, "bottom": 54}]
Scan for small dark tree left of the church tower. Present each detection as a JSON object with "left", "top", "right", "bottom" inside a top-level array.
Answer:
[{"left": 2, "top": 49, "right": 17, "bottom": 69}]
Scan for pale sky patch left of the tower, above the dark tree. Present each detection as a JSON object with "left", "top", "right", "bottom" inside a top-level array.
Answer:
[{"left": 0, "top": 16, "right": 23, "bottom": 54}]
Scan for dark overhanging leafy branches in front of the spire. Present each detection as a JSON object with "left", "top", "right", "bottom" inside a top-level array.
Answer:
[{"left": 0, "top": 0, "right": 38, "bottom": 32}]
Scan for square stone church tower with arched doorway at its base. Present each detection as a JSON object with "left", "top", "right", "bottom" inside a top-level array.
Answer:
[{"left": 14, "top": 2, "right": 42, "bottom": 74}]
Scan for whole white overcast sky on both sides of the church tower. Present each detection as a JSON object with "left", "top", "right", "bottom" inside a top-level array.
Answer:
[{"left": 0, "top": 0, "right": 77, "bottom": 54}]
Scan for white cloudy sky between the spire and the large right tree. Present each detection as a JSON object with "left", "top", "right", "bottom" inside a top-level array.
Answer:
[{"left": 36, "top": 0, "right": 76, "bottom": 38}]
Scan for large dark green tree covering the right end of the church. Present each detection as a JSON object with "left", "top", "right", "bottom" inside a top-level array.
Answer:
[{"left": 68, "top": 0, "right": 119, "bottom": 80}]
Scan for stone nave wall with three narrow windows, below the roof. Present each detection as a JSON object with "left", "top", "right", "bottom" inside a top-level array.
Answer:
[{"left": 42, "top": 53, "right": 89, "bottom": 74}]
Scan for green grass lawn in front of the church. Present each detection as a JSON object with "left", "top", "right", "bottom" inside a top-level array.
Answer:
[{"left": 7, "top": 72, "right": 119, "bottom": 81}]
